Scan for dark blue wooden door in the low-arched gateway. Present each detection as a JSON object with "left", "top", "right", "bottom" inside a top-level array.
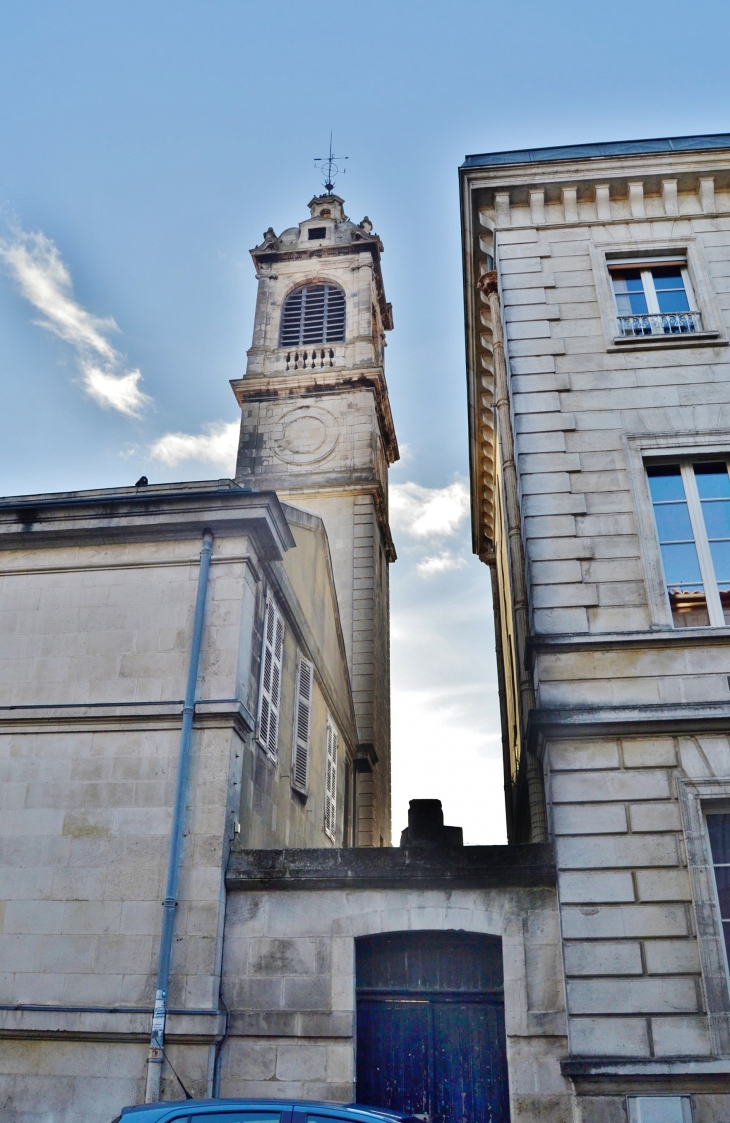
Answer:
[{"left": 355, "top": 931, "right": 509, "bottom": 1123}]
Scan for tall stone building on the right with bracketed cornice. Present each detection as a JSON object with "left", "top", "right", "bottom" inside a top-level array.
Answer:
[{"left": 460, "top": 135, "right": 730, "bottom": 1123}]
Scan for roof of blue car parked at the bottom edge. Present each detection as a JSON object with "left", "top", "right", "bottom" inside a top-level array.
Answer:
[{"left": 113, "top": 1099, "right": 426, "bottom": 1123}]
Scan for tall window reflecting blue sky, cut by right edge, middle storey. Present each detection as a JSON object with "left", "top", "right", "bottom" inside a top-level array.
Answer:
[{"left": 647, "top": 460, "right": 730, "bottom": 628}]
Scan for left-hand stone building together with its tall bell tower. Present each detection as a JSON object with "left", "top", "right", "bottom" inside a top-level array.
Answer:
[{"left": 0, "top": 195, "right": 398, "bottom": 1123}]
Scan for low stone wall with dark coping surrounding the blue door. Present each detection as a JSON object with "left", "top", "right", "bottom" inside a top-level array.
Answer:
[{"left": 221, "top": 846, "right": 571, "bottom": 1123}]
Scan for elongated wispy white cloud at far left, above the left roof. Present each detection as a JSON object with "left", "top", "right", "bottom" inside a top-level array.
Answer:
[{"left": 0, "top": 230, "right": 152, "bottom": 417}]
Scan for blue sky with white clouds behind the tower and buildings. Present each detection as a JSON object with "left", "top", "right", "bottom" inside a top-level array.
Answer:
[{"left": 0, "top": 0, "right": 730, "bottom": 843}]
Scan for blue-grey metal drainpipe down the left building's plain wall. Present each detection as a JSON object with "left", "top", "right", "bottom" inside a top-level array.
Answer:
[{"left": 145, "top": 530, "right": 213, "bottom": 1104}]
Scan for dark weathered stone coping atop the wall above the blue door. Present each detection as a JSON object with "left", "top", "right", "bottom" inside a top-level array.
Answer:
[{"left": 226, "top": 843, "right": 556, "bottom": 891}]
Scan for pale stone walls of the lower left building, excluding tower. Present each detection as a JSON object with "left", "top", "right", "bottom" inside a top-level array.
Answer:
[{"left": 0, "top": 481, "right": 356, "bottom": 1123}]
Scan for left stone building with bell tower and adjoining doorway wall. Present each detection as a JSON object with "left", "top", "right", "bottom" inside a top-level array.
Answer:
[{"left": 0, "top": 194, "right": 571, "bottom": 1123}]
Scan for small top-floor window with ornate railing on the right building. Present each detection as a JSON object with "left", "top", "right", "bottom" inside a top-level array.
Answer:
[{"left": 609, "top": 258, "right": 702, "bottom": 336}]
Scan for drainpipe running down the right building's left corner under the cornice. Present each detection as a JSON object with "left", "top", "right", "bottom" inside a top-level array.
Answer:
[{"left": 478, "top": 271, "right": 548, "bottom": 842}]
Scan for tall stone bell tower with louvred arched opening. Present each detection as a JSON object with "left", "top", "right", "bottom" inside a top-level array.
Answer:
[{"left": 231, "top": 194, "right": 399, "bottom": 846}]
